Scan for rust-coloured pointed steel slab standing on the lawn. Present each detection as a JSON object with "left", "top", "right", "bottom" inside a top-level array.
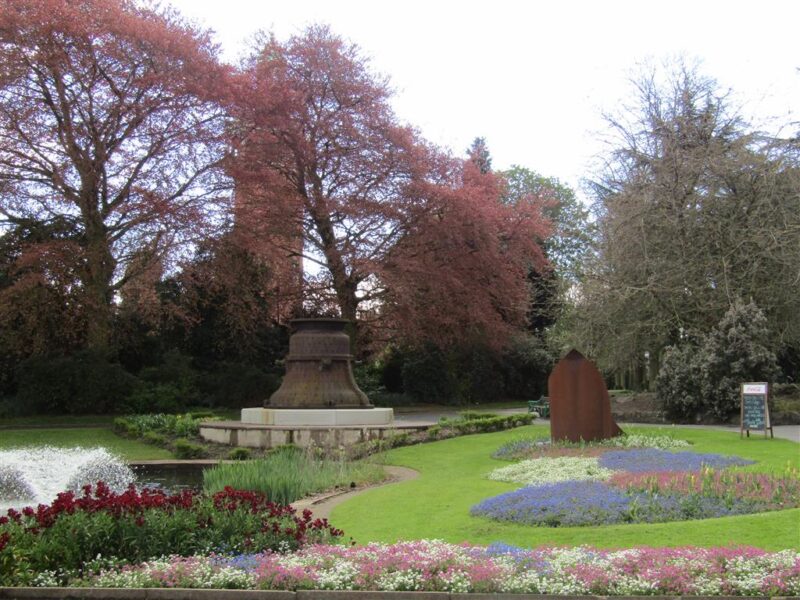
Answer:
[{"left": 547, "top": 350, "right": 622, "bottom": 442}]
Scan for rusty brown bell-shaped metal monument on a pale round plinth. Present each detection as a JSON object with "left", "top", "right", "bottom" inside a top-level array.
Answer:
[{"left": 264, "top": 319, "right": 373, "bottom": 409}]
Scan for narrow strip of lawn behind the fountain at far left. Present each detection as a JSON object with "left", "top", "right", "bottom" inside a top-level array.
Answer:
[{"left": 0, "top": 427, "right": 173, "bottom": 460}]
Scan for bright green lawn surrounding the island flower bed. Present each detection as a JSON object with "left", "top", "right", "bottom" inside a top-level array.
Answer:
[{"left": 331, "top": 425, "right": 800, "bottom": 550}]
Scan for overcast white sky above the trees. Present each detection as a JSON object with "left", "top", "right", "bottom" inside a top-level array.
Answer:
[{"left": 168, "top": 0, "right": 800, "bottom": 200}]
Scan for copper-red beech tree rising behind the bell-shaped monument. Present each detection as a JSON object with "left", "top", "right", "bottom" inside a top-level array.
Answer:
[{"left": 230, "top": 27, "right": 548, "bottom": 343}]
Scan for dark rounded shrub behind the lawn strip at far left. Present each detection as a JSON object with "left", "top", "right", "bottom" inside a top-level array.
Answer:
[{"left": 16, "top": 351, "right": 137, "bottom": 414}]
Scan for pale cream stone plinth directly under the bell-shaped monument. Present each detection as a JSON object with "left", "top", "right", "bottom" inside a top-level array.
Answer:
[{"left": 242, "top": 407, "right": 394, "bottom": 427}]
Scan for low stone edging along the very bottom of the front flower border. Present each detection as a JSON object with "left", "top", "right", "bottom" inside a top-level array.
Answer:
[{"left": 0, "top": 587, "right": 800, "bottom": 600}]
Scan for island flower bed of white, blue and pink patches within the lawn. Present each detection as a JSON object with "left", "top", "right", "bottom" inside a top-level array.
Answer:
[{"left": 470, "top": 448, "right": 800, "bottom": 527}]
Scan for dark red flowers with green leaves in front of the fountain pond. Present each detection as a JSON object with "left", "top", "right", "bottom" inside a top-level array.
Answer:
[{"left": 0, "top": 482, "right": 342, "bottom": 585}]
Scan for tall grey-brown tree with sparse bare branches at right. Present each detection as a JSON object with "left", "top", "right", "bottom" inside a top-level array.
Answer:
[{"left": 578, "top": 65, "right": 800, "bottom": 376}]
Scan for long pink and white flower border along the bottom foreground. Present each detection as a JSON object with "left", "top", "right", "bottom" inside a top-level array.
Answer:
[{"left": 71, "top": 540, "right": 800, "bottom": 596}]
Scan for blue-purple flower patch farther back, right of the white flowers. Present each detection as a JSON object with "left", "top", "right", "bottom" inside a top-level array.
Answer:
[{"left": 599, "top": 448, "right": 754, "bottom": 473}]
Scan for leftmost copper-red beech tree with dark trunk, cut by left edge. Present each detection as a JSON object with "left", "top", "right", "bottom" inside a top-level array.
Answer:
[{"left": 0, "top": 0, "right": 231, "bottom": 350}]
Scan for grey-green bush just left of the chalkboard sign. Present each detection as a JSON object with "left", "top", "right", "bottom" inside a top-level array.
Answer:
[{"left": 656, "top": 302, "right": 778, "bottom": 419}]
